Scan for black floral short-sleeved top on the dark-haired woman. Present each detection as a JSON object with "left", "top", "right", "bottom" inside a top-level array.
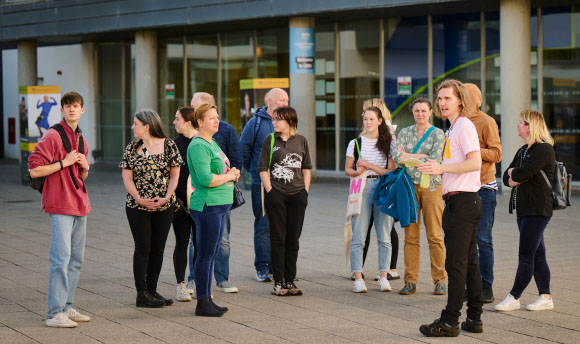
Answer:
[{"left": 119, "top": 139, "right": 185, "bottom": 211}]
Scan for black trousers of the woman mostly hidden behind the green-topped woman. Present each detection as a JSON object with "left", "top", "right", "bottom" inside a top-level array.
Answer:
[{"left": 173, "top": 208, "right": 197, "bottom": 283}]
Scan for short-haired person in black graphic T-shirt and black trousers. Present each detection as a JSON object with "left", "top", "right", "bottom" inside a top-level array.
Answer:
[{"left": 258, "top": 106, "right": 312, "bottom": 296}]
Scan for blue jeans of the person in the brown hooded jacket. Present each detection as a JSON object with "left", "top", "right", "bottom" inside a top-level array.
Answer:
[{"left": 477, "top": 189, "right": 497, "bottom": 288}]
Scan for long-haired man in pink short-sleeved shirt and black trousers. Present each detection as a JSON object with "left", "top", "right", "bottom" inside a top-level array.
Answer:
[{"left": 418, "top": 79, "right": 483, "bottom": 337}]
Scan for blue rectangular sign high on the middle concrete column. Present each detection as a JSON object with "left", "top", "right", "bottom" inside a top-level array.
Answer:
[{"left": 290, "top": 27, "right": 314, "bottom": 74}]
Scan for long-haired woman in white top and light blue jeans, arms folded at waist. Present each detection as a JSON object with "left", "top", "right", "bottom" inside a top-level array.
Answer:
[{"left": 345, "top": 106, "right": 396, "bottom": 293}]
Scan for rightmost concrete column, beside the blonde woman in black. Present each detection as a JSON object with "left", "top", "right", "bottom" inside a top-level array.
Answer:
[{"left": 499, "top": 0, "right": 531, "bottom": 177}]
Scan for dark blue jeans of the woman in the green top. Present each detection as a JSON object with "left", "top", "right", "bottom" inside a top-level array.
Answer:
[{"left": 190, "top": 204, "right": 232, "bottom": 299}]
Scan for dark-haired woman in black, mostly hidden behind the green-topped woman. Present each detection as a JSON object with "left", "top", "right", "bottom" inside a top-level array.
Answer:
[{"left": 173, "top": 107, "right": 197, "bottom": 302}]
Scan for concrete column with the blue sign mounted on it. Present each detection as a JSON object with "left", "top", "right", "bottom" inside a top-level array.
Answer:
[{"left": 289, "top": 17, "right": 316, "bottom": 176}]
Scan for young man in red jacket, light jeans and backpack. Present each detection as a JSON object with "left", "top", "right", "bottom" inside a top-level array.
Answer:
[{"left": 28, "top": 92, "right": 91, "bottom": 327}]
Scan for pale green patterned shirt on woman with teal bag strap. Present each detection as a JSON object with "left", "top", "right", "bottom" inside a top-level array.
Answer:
[{"left": 393, "top": 125, "right": 445, "bottom": 184}]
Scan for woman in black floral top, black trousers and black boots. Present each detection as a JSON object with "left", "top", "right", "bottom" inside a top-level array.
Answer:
[{"left": 119, "top": 109, "right": 184, "bottom": 307}]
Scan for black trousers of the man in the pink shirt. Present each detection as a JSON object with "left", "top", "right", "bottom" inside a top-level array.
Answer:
[{"left": 441, "top": 192, "right": 483, "bottom": 325}]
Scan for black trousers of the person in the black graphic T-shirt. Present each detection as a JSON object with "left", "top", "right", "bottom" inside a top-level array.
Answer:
[{"left": 264, "top": 188, "right": 308, "bottom": 282}]
